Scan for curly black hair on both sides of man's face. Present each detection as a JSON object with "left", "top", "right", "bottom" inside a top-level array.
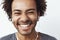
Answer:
[{"left": 3, "top": 0, "right": 47, "bottom": 19}]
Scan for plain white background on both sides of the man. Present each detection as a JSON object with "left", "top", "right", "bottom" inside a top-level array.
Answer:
[{"left": 0, "top": 0, "right": 60, "bottom": 40}]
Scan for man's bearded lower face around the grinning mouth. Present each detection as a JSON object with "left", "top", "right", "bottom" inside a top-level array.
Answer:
[{"left": 13, "top": 20, "right": 37, "bottom": 35}]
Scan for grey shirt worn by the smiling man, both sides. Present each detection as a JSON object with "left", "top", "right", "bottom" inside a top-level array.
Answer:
[{"left": 0, "top": 33, "right": 57, "bottom": 40}]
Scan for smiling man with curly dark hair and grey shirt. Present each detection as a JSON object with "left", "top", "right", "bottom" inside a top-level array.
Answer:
[{"left": 0, "top": 0, "right": 56, "bottom": 40}]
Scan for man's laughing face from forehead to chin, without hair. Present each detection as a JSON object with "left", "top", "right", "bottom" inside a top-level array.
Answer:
[{"left": 12, "top": 0, "right": 38, "bottom": 34}]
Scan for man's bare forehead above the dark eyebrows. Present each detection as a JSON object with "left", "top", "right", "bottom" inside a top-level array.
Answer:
[{"left": 12, "top": 0, "right": 36, "bottom": 10}]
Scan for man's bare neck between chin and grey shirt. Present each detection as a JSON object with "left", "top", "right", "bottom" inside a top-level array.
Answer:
[{"left": 16, "top": 31, "right": 37, "bottom": 40}]
